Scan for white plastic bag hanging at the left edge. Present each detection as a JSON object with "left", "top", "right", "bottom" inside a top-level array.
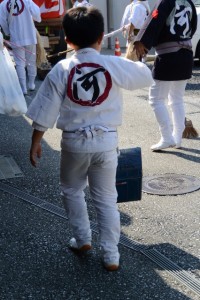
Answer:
[{"left": 0, "top": 32, "right": 27, "bottom": 116}]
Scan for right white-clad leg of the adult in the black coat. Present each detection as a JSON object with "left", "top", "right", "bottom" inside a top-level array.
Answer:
[{"left": 168, "top": 80, "right": 187, "bottom": 148}]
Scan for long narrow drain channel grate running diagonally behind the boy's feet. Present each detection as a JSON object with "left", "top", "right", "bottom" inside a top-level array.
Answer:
[{"left": 0, "top": 182, "right": 200, "bottom": 296}]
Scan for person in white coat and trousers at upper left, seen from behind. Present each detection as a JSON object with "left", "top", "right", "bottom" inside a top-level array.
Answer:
[{"left": 0, "top": 0, "right": 41, "bottom": 95}]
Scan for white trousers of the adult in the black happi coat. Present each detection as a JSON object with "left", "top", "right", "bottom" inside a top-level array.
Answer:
[{"left": 149, "top": 80, "right": 187, "bottom": 144}]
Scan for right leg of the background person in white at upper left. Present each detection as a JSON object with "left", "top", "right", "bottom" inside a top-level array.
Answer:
[{"left": 26, "top": 45, "right": 37, "bottom": 91}]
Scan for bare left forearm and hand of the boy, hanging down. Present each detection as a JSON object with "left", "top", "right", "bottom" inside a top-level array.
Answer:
[{"left": 30, "top": 129, "right": 45, "bottom": 167}]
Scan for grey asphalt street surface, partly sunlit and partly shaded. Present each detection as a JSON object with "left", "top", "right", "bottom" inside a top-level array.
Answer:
[{"left": 0, "top": 50, "right": 200, "bottom": 300}]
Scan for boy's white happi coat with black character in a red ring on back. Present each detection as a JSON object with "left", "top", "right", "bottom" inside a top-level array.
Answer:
[{"left": 27, "top": 48, "right": 153, "bottom": 151}]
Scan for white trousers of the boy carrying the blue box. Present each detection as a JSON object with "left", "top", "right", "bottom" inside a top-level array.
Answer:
[{"left": 60, "top": 150, "right": 120, "bottom": 263}]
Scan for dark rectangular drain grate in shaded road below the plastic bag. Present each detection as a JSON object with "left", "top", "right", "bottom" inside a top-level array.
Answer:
[{"left": 0, "top": 155, "right": 24, "bottom": 180}]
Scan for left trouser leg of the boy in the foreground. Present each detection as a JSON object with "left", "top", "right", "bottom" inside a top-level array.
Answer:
[{"left": 60, "top": 150, "right": 91, "bottom": 248}]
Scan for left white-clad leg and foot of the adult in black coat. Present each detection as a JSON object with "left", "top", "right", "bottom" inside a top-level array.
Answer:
[{"left": 149, "top": 80, "right": 175, "bottom": 150}]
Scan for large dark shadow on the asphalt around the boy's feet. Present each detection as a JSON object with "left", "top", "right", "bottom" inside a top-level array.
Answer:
[{"left": 0, "top": 95, "right": 197, "bottom": 300}]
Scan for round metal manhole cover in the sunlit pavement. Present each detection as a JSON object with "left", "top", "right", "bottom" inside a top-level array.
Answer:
[{"left": 142, "top": 173, "right": 200, "bottom": 196}]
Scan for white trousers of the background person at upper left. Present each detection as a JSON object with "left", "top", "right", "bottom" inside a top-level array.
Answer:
[{"left": 13, "top": 45, "right": 37, "bottom": 94}]
